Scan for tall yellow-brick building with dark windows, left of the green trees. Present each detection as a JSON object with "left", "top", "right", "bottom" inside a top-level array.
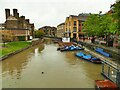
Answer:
[{"left": 64, "top": 13, "right": 89, "bottom": 40}]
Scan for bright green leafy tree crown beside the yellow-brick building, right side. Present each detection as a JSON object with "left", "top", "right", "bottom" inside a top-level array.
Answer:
[{"left": 83, "top": 14, "right": 117, "bottom": 36}]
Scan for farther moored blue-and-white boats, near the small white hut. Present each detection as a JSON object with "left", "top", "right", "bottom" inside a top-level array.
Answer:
[{"left": 58, "top": 45, "right": 84, "bottom": 51}]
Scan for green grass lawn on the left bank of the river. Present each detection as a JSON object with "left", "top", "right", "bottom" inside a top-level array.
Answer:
[{"left": 0, "top": 41, "right": 31, "bottom": 57}]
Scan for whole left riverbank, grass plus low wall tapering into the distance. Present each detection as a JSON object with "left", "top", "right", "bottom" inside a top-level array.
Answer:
[{"left": 0, "top": 39, "right": 43, "bottom": 61}]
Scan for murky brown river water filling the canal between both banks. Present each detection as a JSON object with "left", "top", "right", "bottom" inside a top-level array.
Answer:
[{"left": 0, "top": 39, "right": 104, "bottom": 88}]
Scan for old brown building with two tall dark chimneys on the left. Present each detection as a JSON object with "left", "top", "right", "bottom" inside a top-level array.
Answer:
[{"left": 0, "top": 9, "right": 34, "bottom": 40}]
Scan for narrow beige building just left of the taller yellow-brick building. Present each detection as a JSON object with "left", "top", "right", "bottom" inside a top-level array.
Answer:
[{"left": 57, "top": 23, "right": 65, "bottom": 38}]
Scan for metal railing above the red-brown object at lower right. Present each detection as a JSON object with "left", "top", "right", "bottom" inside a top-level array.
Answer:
[{"left": 102, "top": 60, "right": 120, "bottom": 87}]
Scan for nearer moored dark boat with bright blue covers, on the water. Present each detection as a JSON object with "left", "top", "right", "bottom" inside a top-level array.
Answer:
[{"left": 75, "top": 52, "right": 102, "bottom": 64}]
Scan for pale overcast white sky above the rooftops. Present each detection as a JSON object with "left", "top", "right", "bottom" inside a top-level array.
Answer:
[{"left": 0, "top": 0, "right": 116, "bottom": 29}]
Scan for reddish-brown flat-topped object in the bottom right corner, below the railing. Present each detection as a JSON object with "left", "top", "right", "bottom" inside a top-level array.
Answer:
[{"left": 95, "top": 79, "right": 120, "bottom": 90}]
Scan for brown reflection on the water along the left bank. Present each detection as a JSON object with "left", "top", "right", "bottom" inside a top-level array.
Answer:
[{"left": 1, "top": 44, "right": 44, "bottom": 79}]
